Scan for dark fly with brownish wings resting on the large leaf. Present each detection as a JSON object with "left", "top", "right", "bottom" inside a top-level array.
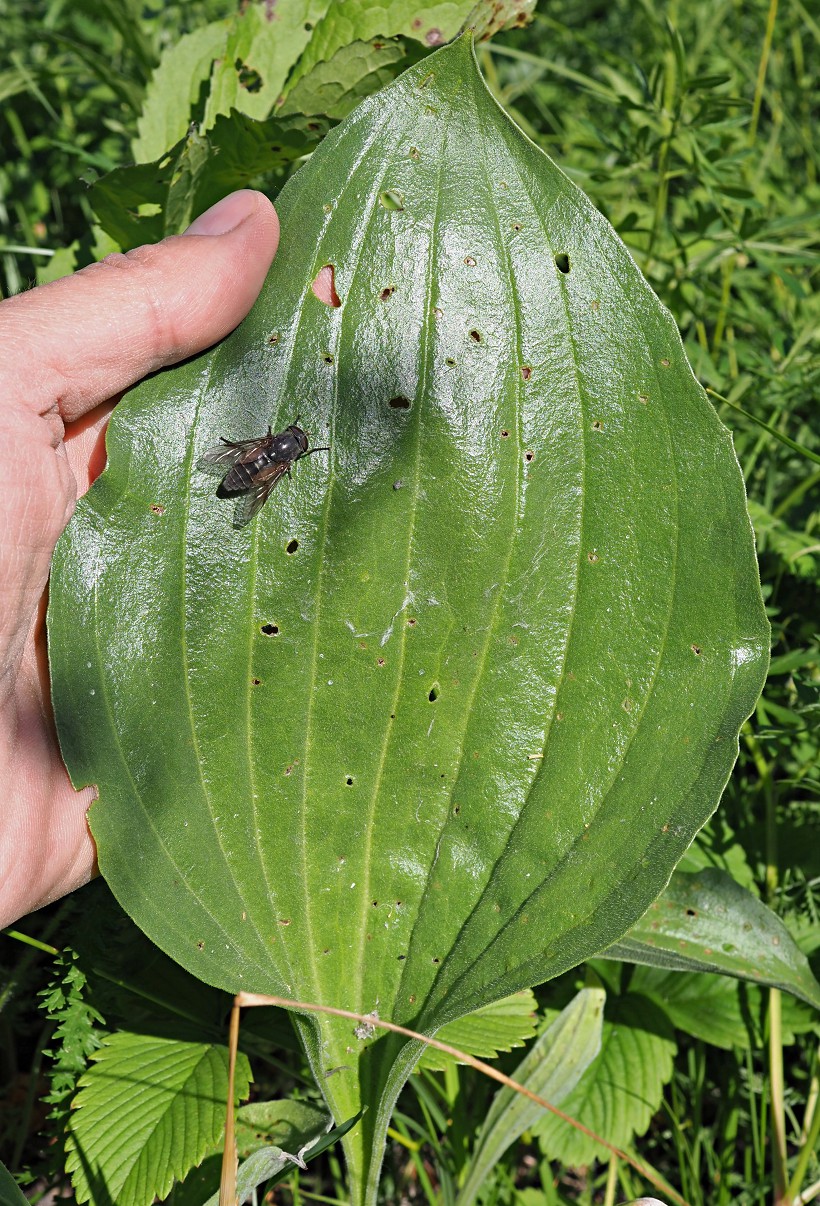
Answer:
[{"left": 199, "top": 418, "right": 329, "bottom": 528}]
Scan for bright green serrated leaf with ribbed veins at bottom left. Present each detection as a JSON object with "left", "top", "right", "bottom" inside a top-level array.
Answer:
[{"left": 66, "top": 1031, "right": 251, "bottom": 1206}]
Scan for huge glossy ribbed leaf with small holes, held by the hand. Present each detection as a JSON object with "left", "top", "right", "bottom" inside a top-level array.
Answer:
[{"left": 51, "top": 40, "right": 768, "bottom": 1200}]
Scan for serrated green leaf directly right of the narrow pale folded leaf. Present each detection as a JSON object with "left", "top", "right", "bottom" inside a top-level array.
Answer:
[{"left": 533, "top": 993, "right": 675, "bottom": 1167}]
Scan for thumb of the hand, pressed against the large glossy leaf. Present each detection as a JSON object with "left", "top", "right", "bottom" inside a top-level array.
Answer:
[{"left": 0, "top": 189, "right": 279, "bottom": 421}]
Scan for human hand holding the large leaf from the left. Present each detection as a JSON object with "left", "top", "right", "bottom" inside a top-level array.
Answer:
[{"left": 0, "top": 189, "right": 279, "bottom": 926}]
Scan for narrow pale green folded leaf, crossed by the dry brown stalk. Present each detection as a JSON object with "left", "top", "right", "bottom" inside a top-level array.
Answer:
[{"left": 458, "top": 988, "right": 607, "bottom": 1206}]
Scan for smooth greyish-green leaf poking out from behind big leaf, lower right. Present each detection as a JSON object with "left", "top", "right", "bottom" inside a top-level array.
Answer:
[{"left": 604, "top": 867, "right": 820, "bottom": 1008}]
